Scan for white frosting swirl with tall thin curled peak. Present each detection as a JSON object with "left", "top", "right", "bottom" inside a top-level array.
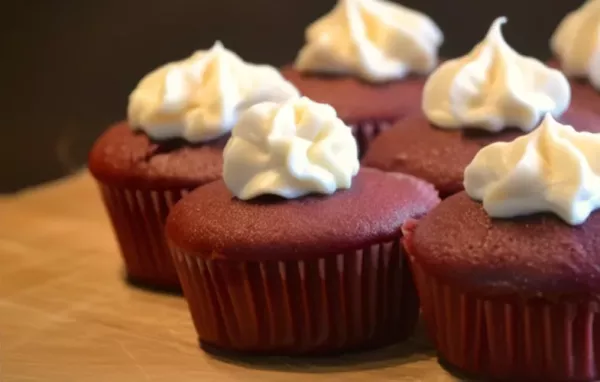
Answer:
[{"left": 423, "top": 17, "right": 571, "bottom": 132}]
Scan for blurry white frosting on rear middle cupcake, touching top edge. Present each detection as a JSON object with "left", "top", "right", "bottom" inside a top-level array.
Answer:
[{"left": 296, "top": 0, "right": 444, "bottom": 82}]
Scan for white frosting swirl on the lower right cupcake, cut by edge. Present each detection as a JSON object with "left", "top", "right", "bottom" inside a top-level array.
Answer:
[{"left": 464, "top": 114, "right": 600, "bottom": 225}]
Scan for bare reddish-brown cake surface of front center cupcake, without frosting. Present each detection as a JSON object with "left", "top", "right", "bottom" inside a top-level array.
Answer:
[{"left": 167, "top": 169, "right": 439, "bottom": 260}]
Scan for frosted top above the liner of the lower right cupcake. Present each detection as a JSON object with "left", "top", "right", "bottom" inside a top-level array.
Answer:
[{"left": 407, "top": 114, "right": 600, "bottom": 297}]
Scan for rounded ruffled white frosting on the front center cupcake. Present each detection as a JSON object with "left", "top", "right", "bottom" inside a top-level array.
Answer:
[{"left": 223, "top": 97, "right": 359, "bottom": 200}]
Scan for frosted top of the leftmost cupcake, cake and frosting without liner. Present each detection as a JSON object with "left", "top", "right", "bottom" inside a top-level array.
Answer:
[{"left": 89, "top": 42, "right": 298, "bottom": 189}]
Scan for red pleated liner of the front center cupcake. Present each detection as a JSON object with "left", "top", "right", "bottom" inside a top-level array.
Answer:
[{"left": 172, "top": 240, "right": 419, "bottom": 355}]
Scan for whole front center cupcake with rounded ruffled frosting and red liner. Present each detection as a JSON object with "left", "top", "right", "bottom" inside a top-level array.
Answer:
[{"left": 166, "top": 98, "right": 438, "bottom": 355}]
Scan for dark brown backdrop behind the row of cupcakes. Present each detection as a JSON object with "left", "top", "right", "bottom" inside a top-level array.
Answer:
[{"left": 0, "top": 0, "right": 583, "bottom": 192}]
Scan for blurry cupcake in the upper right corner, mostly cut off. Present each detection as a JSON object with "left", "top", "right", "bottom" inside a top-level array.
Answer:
[{"left": 550, "top": 0, "right": 600, "bottom": 113}]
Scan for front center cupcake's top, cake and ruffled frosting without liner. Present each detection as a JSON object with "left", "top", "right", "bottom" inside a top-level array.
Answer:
[{"left": 167, "top": 98, "right": 439, "bottom": 260}]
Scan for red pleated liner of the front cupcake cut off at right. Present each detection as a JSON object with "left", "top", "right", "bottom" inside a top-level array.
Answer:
[{"left": 411, "top": 258, "right": 600, "bottom": 381}]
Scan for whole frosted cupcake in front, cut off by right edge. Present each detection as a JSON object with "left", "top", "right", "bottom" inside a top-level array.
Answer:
[{"left": 404, "top": 114, "right": 600, "bottom": 381}]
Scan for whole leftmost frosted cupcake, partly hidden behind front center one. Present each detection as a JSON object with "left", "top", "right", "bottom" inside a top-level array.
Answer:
[{"left": 89, "top": 42, "right": 298, "bottom": 289}]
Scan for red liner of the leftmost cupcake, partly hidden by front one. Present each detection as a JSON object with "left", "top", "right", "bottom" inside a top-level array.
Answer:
[{"left": 100, "top": 184, "right": 189, "bottom": 290}]
